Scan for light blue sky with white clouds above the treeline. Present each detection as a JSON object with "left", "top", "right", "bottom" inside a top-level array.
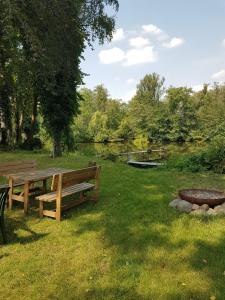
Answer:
[{"left": 81, "top": 0, "right": 225, "bottom": 102}]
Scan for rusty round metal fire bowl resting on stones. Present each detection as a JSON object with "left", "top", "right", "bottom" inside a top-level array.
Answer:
[{"left": 179, "top": 189, "right": 225, "bottom": 206}]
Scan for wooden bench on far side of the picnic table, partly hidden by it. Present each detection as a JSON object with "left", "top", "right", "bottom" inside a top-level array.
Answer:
[{"left": 0, "top": 160, "right": 40, "bottom": 209}]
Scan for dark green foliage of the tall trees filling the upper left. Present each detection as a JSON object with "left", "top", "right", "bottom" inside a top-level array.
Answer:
[{"left": 0, "top": 0, "right": 119, "bottom": 155}]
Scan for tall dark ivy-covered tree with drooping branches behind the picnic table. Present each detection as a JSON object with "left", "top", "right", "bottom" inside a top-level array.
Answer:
[{"left": 10, "top": 0, "right": 118, "bottom": 156}]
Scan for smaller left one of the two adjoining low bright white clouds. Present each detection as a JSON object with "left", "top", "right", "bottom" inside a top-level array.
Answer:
[{"left": 98, "top": 47, "right": 125, "bottom": 64}]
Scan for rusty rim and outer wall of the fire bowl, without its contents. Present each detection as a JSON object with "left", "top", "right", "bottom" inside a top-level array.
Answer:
[{"left": 178, "top": 189, "right": 225, "bottom": 206}]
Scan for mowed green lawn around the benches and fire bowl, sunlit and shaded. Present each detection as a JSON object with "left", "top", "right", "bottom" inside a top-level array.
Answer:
[{"left": 0, "top": 152, "right": 225, "bottom": 300}]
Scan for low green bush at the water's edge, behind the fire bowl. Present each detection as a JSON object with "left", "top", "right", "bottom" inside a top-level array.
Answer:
[{"left": 167, "top": 136, "right": 225, "bottom": 173}]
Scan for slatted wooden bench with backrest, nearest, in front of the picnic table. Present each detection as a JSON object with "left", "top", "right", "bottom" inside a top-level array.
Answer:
[{"left": 36, "top": 165, "right": 101, "bottom": 221}]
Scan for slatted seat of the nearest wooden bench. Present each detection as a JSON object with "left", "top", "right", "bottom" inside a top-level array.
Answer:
[{"left": 36, "top": 182, "right": 95, "bottom": 202}]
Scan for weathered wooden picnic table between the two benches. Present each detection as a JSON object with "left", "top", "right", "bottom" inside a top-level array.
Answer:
[{"left": 6, "top": 168, "right": 73, "bottom": 214}]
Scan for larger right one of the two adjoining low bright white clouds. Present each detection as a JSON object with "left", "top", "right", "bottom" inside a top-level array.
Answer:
[{"left": 124, "top": 46, "right": 158, "bottom": 66}]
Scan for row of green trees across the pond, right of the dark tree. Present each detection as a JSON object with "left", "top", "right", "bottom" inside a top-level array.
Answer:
[{"left": 72, "top": 73, "right": 225, "bottom": 143}]
